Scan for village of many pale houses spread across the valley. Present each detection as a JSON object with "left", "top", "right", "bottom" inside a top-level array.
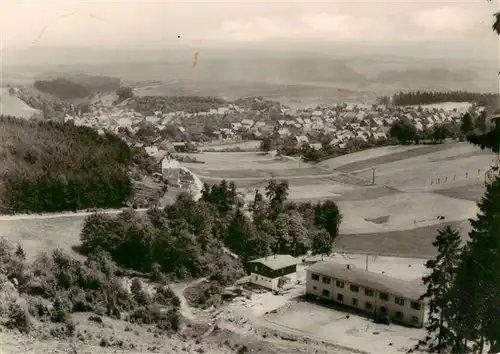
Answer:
[{"left": 60, "top": 94, "right": 481, "bottom": 161}]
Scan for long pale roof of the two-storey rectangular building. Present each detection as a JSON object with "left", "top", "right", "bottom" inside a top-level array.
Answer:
[{"left": 307, "top": 261, "right": 425, "bottom": 300}]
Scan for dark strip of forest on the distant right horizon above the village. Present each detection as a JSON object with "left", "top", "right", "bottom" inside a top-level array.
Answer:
[{"left": 380, "top": 91, "right": 498, "bottom": 107}]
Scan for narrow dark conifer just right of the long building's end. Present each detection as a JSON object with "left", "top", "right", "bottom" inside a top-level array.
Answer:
[{"left": 421, "top": 225, "right": 460, "bottom": 353}]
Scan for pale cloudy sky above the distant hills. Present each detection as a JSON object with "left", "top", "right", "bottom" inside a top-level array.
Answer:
[{"left": 0, "top": 0, "right": 500, "bottom": 54}]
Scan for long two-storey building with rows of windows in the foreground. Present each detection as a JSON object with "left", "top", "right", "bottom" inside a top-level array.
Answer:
[{"left": 306, "top": 261, "right": 425, "bottom": 327}]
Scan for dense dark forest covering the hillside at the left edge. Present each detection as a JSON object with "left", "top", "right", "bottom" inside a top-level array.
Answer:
[{"left": 0, "top": 116, "right": 133, "bottom": 213}]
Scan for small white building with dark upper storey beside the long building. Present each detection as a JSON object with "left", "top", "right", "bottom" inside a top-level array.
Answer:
[{"left": 247, "top": 254, "right": 299, "bottom": 290}]
